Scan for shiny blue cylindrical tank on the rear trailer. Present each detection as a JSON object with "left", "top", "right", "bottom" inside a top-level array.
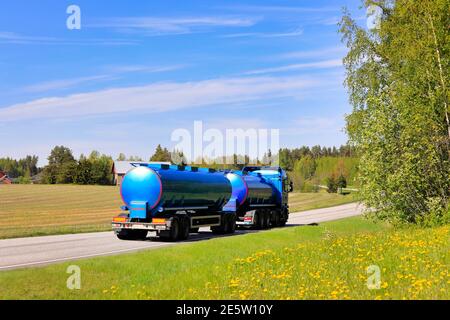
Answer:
[{"left": 121, "top": 165, "right": 232, "bottom": 213}]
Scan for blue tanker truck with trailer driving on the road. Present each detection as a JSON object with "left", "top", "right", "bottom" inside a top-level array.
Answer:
[{"left": 112, "top": 163, "right": 292, "bottom": 241}]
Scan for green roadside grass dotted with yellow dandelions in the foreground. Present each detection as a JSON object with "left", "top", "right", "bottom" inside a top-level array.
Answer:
[{"left": 0, "top": 217, "right": 450, "bottom": 299}]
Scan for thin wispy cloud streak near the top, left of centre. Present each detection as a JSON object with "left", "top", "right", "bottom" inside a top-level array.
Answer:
[{"left": 87, "top": 16, "right": 259, "bottom": 35}]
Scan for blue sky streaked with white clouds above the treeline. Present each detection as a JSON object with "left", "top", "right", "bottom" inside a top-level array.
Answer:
[{"left": 0, "top": 0, "right": 365, "bottom": 164}]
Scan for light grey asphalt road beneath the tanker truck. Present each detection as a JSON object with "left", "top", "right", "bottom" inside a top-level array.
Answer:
[{"left": 0, "top": 203, "right": 362, "bottom": 270}]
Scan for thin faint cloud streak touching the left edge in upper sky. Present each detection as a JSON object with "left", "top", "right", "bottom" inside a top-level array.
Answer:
[{"left": 0, "top": 31, "right": 139, "bottom": 46}]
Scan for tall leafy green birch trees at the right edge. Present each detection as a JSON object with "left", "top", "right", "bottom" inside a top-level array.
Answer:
[{"left": 340, "top": 0, "right": 450, "bottom": 223}]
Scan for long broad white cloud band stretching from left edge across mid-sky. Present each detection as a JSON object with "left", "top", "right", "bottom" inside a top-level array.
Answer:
[{"left": 0, "top": 77, "right": 320, "bottom": 121}]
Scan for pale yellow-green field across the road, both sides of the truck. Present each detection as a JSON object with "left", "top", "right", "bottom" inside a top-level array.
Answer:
[{"left": 0, "top": 185, "right": 354, "bottom": 238}]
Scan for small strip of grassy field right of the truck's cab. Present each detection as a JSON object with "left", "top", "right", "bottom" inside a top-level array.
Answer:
[{"left": 289, "top": 190, "right": 358, "bottom": 212}]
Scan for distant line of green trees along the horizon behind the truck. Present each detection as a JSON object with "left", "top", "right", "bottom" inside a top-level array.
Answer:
[{"left": 0, "top": 145, "right": 358, "bottom": 191}]
